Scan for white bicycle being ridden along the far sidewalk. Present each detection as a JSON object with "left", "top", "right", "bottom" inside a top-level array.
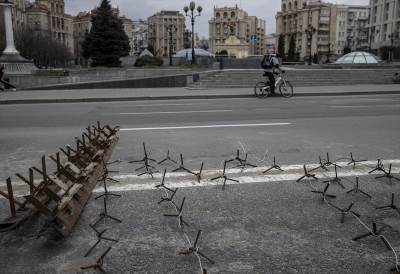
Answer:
[{"left": 254, "top": 70, "right": 293, "bottom": 98}]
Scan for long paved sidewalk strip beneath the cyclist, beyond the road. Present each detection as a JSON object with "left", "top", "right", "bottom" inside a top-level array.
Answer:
[{"left": 0, "top": 84, "right": 400, "bottom": 105}]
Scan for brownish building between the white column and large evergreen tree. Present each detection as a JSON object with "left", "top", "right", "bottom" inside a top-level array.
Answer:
[{"left": 26, "top": 0, "right": 74, "bottom": 54}]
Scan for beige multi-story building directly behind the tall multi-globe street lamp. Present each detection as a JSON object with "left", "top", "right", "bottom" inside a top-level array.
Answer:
[{"left": 147, "top": 10, "right": 185, "bottom": 56}]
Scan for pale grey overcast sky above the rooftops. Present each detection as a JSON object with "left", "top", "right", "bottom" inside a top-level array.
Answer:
[{"left": 65, "top": 0, "right": 369, "bottom": 37}]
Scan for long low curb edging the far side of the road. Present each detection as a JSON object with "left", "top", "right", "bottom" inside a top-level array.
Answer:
[{"left": 0, "top": 90, "right": 400, "bottom": 105}]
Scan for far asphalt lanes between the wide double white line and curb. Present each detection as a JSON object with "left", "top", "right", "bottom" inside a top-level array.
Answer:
[{"left": 0, "top": 95, "right": 400, "bottom": 178}]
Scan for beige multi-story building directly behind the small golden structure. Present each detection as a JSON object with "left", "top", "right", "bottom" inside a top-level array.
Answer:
[{"left": 209, "top": 5, "right": 266, "bottom": 55}]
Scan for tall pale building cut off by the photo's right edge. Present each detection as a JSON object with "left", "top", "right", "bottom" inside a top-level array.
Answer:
[{"left": 369, "top": 0, "right": 400, "bottom": 57}]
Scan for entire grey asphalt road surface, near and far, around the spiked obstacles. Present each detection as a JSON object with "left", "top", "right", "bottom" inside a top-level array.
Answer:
[{"left": 0, "top": 95, "right": 400, "bottom": 274}]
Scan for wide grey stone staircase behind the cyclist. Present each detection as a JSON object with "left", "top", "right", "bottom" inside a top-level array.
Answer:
[{"left": 189, "top": 68, "right": 400, "bottom": 89}]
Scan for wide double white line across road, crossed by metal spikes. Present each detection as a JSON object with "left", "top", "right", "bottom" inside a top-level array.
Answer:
[{"left": 0, "top": 159, "right": 400, "bottom": 196}]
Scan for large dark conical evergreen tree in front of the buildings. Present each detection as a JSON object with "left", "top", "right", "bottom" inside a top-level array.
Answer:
[{"left": 82, "top": 0, "right": 130, "bottom": 67}]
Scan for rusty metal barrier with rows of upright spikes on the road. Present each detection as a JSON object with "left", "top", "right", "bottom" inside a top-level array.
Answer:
[{"left": 0, "top": 122, "right": 119, "bottom": 237}]
